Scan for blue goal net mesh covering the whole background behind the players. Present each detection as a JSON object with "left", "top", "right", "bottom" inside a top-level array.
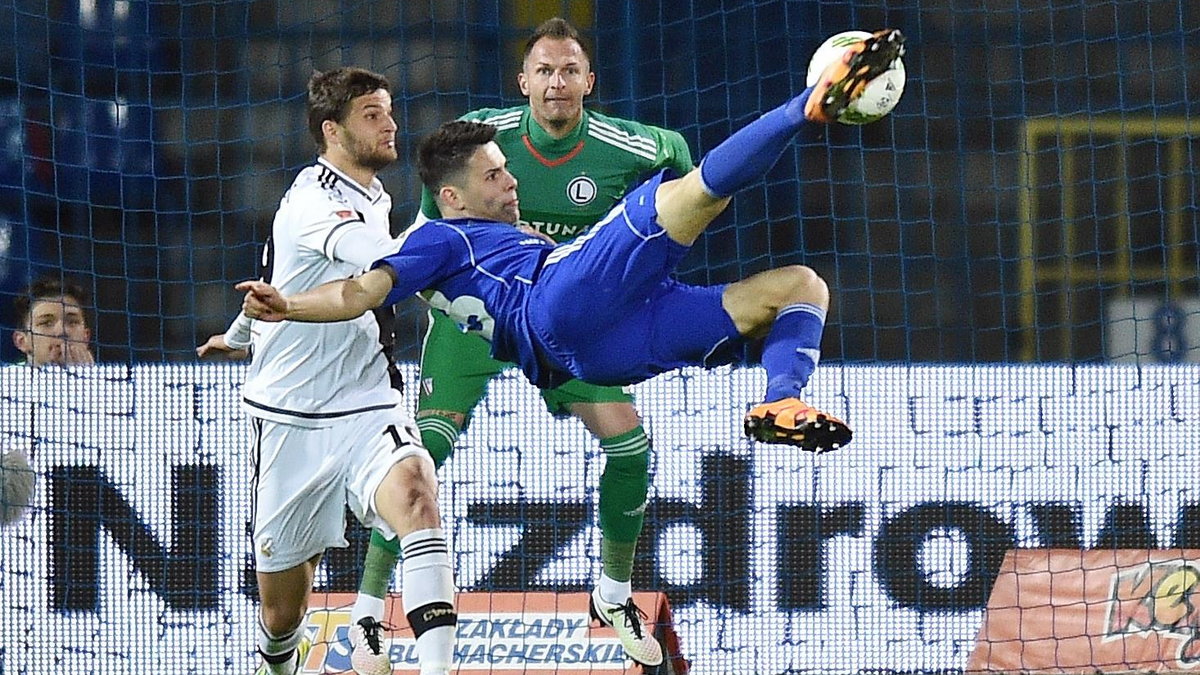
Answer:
[{"left": 0, "top": 0, "right": 1200, "bottom": 673}]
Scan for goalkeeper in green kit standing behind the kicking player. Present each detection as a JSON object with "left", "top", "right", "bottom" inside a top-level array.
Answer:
[{"left": 350, "top": 18, "right": 692, "bottom": 675}]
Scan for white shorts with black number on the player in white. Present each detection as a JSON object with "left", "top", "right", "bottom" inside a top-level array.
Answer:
[{"left": 250, "top": 405, "right": 433, "bottom": 572}]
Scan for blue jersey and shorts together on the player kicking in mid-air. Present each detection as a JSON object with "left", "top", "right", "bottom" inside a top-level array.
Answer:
[{"left": 374, "top": 174, "right": 742, "bottom": 388}]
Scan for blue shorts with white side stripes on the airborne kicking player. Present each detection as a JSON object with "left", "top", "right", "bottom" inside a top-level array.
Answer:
[{"left": 529, "top": 172, "right": 742, "bottom": 384}]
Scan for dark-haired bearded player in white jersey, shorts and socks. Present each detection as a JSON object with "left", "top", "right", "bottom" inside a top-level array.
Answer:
[{"left": 216, "top": 67, "right": 457, "bottom": 675}]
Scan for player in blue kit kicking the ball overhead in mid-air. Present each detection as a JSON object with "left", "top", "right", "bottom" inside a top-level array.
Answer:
[{"left": 238, "top": 30, "right": 904, "bottom": 453}]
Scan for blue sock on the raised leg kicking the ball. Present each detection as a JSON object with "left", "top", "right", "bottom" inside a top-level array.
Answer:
[{"left": 700, "top": 86, "right": 816, "bottom": 197}]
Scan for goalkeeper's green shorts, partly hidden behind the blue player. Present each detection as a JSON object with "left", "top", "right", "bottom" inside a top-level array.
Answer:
[{"left": 416, "top": 311, "right": 634, "bottom": 428}]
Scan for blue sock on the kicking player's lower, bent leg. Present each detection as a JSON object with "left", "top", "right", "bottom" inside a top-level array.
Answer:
[{"left": 762, "top": 303, "right": 826, "bottom": 401}]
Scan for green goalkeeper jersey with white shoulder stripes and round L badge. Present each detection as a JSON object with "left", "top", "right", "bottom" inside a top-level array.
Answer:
[{"left": 421, "top": 104, "right": 692, "bottom": 241}]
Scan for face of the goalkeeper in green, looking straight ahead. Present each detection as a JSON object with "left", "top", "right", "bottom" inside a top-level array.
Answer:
[{"left": 517, "top": 37, "right": 595, "bottom": 131}]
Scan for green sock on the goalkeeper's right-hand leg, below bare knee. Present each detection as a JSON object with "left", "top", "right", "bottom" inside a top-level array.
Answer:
[{"left": 600, "top": 426, "right": 650, "bottom": 581}]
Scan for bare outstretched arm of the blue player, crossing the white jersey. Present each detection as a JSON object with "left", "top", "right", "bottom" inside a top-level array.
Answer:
[{"left": 236, "top": 267, "right": 392, "bottom": 323}]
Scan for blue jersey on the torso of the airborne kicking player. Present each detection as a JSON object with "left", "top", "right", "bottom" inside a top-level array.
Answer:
[{"left": 374, "top": 219, "right": 554, "bottom": 382}]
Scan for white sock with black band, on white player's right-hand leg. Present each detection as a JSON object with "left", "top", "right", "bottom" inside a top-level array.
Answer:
[{"left": 400, "top": 528, "right": 457, "bottom": 674}]
